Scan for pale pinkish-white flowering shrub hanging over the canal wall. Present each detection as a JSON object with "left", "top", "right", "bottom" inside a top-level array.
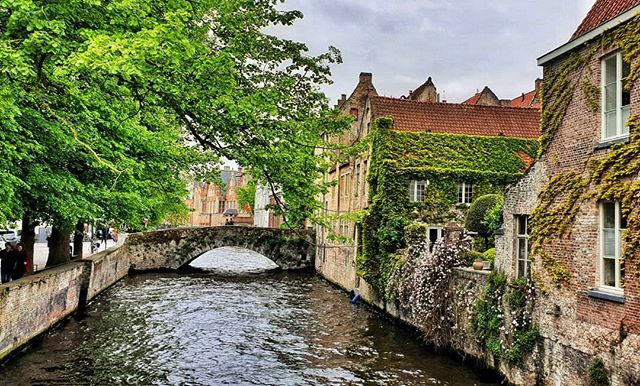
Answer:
[{"left": 387, "top": 228, "right": 471, "bottom": 347}]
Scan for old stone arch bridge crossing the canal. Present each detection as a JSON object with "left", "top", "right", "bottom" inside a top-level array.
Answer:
[{"left": 124, "top": 226, "right": 315, "bottom": 271}]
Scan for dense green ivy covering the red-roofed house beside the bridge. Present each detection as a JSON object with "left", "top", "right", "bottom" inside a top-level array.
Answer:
[{"left": 358, "top": 118, "right": 539, "bottom": 293}]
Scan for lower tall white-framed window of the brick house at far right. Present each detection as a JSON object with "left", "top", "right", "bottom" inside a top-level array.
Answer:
[{"left": 600, "top": 202, "right": 627, "bottom": 291}]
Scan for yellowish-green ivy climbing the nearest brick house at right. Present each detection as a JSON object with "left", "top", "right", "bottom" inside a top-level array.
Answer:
[{"left": 531, "top": 16, "right": 640, "bottom": 286}]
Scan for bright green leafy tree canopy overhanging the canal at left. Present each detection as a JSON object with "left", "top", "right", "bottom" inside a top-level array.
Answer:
[{"left": 0, "top": 0, "right": 346, "bottom": 264}]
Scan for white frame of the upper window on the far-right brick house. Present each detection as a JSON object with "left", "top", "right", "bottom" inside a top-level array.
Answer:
[{"left": 600, "top": 51, "right": 631, "bottom": 141}]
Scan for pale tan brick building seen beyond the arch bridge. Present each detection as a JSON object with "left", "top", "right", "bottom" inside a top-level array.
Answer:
[{"left": 186, "top": 166, "right": 253, "bottom": 226}]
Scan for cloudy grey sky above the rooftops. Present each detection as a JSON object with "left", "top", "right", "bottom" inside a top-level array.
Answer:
[{"left": 278, "top": 0, "right": 595, "bottom": 102}]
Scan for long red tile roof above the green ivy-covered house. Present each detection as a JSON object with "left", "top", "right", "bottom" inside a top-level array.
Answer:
[{"left": 371, "top": 97, "right": 540, "bottom": 138}]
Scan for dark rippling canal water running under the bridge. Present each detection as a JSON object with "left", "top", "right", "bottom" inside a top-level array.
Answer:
[{"left": 0, "top": 248, "right": 493, "bottom": 385}]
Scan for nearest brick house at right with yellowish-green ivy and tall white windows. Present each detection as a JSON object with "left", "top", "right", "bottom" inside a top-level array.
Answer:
[{"left": 496, "top": 0, "right": 640, "bottom": 385}]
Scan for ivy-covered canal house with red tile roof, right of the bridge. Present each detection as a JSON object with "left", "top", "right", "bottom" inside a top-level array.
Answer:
[{"left": 316, "top": 73, "right": 540, "bottom": 298}]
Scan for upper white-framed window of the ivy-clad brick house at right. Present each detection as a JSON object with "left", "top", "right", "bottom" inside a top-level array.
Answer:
[{"left": 602, "top": 52, "right": 631, "bottom": 140}]
